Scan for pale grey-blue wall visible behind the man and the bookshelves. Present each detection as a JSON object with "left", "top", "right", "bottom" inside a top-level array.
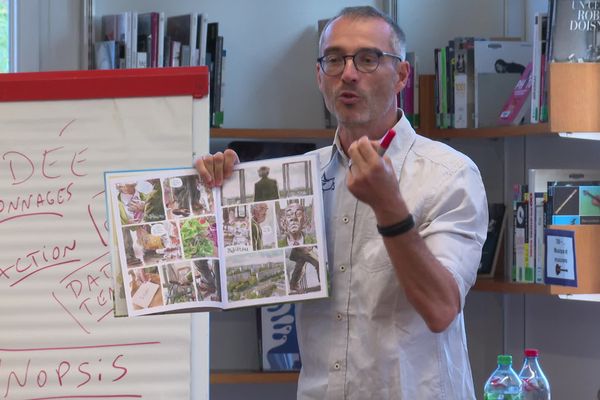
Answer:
[{"left": 18, "top": 0, "right": 600, "bottom": 399}]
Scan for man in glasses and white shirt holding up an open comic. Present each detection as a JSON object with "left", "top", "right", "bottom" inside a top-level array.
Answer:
[{"left": 196, "top": 7, "right": 488, "bottom": 400}]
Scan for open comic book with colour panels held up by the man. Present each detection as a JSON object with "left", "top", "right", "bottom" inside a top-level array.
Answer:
[{"left": 105, "top": 155, "right": 328, "bottom": 316}]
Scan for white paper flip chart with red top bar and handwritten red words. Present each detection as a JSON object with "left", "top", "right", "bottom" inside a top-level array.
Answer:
[{"left": 0, "top": 67, "right": 209, "bottom": 399}]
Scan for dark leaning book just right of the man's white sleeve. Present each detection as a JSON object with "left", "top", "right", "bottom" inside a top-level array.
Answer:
[{"left": 477, "top": 203, "right": 506, "bottom": 278}]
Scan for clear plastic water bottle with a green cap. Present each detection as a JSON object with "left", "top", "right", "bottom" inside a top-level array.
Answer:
[{"left": 483, "top": 354, "right": 522, "bottom": 400}]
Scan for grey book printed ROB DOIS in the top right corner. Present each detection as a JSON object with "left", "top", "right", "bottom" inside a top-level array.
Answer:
[{"left": 550, "top": 0, "right": 600, "bottom": 62}]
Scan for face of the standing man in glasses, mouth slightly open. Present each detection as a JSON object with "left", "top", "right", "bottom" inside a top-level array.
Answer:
[{"left": 317, "top": 17, "right": 407, "bottom": 126}]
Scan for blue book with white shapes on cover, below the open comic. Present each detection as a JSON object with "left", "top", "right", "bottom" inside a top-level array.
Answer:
[{"left": 258, "top": 304, "right": 302, "bottom": 371}]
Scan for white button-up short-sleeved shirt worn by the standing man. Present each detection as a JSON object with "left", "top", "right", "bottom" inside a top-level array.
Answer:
[{"left": 297, "top": 116, "right": 488, "bottom": 400}]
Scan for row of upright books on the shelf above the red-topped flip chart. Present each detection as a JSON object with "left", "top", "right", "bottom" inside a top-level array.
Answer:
[{"left": 92, "top": 11, "right": 226, "bottom": 127}]
